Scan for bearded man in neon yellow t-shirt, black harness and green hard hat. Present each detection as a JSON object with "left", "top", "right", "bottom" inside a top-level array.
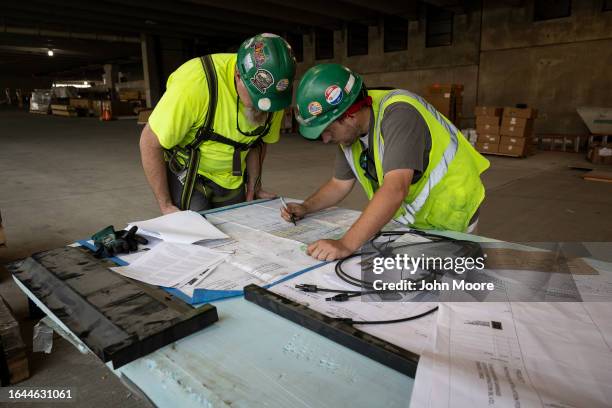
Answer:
[{"left": 140, "top": 33, "right": 295, "bottom": 214}]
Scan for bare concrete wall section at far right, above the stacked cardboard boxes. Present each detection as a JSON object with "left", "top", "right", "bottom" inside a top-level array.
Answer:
[{"left": 478, "top": 0, "right": 612, "bottom": 134}]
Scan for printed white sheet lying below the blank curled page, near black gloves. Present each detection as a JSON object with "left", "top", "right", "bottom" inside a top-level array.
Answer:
[{"left": 110, "top": 242, "right": 228, "bottom": 287}]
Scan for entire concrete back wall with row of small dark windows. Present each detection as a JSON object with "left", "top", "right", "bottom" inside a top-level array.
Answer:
[{"left": 298, "top": 0, "right": 612, "bottom": 134}]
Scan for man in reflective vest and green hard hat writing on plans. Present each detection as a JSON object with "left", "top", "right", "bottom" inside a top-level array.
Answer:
[{"left": 281, "top": 64, "right": 489, "bottom": 261}]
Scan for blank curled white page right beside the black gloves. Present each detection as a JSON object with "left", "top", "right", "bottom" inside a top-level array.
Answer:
[{"left": 129, "top": 211, "right": 227, "bottom": 244}]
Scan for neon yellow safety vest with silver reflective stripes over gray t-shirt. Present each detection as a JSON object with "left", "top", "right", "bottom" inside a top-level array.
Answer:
[{"left": 340, "top": 89, "right": 489, "bottom": 231}]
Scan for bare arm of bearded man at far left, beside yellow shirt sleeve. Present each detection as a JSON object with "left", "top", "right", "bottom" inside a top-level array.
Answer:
[{"left": 140, "top": 124, "right": 180, "bottom": 214}]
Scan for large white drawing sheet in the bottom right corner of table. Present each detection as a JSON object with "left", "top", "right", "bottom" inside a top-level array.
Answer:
[{"left": 424, "top": 302, "right": 612, "bottom": 408}]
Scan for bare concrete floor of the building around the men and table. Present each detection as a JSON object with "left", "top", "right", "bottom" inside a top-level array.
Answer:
[{"left": 0, "top": 110, "right": 612, "bottom": 407}]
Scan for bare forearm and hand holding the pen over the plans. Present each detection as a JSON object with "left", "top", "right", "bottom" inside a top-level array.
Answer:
[{"left": 281, "top": 177, "right": 355, "bottom": 221}]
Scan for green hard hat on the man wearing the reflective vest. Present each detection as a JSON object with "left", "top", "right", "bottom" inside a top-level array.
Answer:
[{"left": 295, "top": 64, "right": 363, "bottom": 139}]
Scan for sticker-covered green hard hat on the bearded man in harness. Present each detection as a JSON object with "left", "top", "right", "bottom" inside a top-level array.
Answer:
[{"left": 237, "top": 33, "right": 295, "bottom": 112}]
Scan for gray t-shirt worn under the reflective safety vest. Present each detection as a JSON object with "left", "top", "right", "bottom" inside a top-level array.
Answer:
[{"left": 334, "top": 102, "right": 431, "bottom": 184}]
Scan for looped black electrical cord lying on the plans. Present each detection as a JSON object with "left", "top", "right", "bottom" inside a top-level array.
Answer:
[{"left": 295, "top": 230, "right": 482, "bottom": 325}]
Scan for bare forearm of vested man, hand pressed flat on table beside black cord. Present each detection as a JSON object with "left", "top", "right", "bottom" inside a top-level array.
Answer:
[{"left": 306, "top": 169, "right": 414, "bottom": 261}]
